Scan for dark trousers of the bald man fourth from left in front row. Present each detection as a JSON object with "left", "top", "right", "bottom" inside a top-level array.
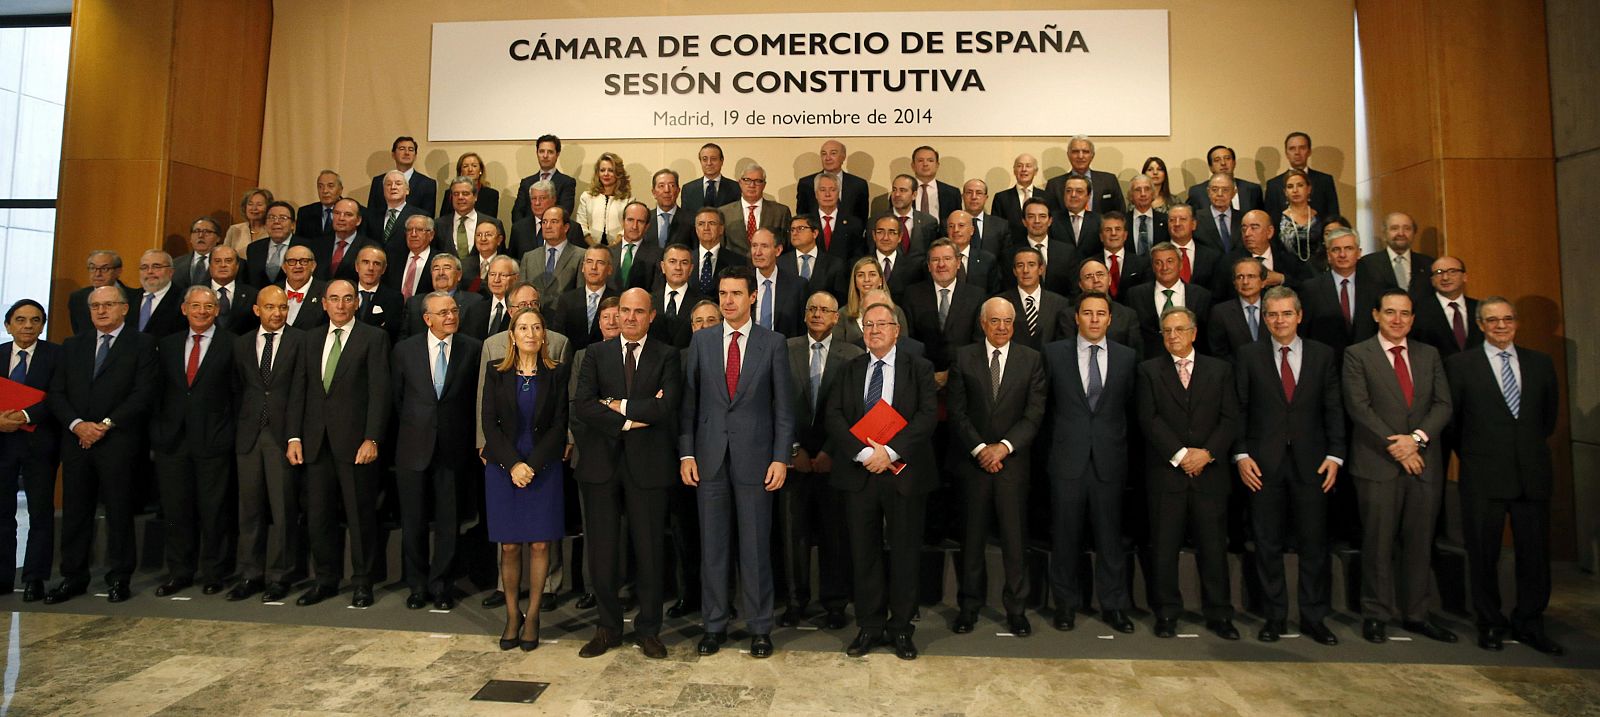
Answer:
[{"left": 238, "top": 431, "right": 301, "bottom": 583}]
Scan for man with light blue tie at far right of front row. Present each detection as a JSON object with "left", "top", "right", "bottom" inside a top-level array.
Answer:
[{"left": 1445, "top": 296, "right": 1565, "bottom": 655}]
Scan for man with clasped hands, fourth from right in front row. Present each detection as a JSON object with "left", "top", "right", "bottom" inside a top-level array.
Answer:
[{"left": 1136, "top": 306, "right": 1240, "bottom": 640}]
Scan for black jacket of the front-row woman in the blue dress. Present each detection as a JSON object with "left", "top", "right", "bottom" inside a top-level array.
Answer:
[{"left": 483, "top": 362, "right": 569, "bottom": 472}]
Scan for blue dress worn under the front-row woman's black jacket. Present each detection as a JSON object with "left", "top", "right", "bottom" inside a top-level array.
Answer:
[{"left": 483, "top": 375, "right": 566, "bottom": 543}]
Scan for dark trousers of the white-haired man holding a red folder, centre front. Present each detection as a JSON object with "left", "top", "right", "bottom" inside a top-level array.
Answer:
[{"left": 845, "top": 474, "right": 928, "bottom": 635}]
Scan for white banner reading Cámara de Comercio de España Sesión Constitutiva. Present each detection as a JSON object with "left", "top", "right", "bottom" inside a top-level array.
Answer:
[{"left": 427, "top": 10, "right": 1171, "bottom": 141}]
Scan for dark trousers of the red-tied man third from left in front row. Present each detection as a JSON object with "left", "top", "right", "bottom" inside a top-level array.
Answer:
[{"left": 155, "top": 448, "right": 237, "bottom": 583}]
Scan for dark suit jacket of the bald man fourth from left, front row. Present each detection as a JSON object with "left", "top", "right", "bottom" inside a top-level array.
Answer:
[{"left": 232, "top": 326, "right": 305, "bottom": 455}]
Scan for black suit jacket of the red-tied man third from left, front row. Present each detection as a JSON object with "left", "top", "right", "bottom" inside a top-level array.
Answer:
[{"left": 150, "top": 326, "right": 237, "bottom": 456}]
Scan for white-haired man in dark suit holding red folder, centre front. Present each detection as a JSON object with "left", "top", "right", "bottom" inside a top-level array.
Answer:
[{"left": 826, "top": 304, "right": 939, "bottom": 659}]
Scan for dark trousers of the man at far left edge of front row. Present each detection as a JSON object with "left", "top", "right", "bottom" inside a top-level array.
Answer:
[{"left": 0, "top": 451, "right": 56, "bottom": 587}]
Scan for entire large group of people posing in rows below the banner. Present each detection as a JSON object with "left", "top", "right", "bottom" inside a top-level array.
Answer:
[{"left": 0, "top": 133, "right": 1562, "bottom": 659}]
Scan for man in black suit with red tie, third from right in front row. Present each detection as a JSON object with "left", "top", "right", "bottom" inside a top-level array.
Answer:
[{"left": 1222, "top": 286, "right": 1346, "bottom": 645}]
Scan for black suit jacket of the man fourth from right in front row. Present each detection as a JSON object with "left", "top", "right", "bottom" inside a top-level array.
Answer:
[{"left": 1136, "top": 350, "right": 1240, "bottom": 496}]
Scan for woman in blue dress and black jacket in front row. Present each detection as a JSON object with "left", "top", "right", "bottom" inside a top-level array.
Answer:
[{"left": 483, "top": 309, "right": 570, "bottom": 651}]
